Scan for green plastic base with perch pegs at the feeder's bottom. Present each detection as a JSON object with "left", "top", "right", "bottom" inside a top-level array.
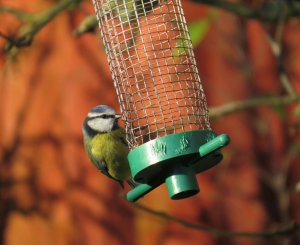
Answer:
[{"left": 127, "top": 130, "right": 229, "bottom": 202}]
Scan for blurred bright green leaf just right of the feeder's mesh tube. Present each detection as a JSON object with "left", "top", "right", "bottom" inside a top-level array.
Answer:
[{"left": 188, "top": 18, "right": 210, "bottom": 48}]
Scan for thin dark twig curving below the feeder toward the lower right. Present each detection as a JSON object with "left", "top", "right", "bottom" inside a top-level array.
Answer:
[{"left": 133, "top": 203, "right": 300, "bottom": 238}]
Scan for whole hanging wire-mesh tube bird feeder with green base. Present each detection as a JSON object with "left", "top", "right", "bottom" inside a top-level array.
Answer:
[{"left": 93, "top": 0, "right": 229, "bottom": 201}]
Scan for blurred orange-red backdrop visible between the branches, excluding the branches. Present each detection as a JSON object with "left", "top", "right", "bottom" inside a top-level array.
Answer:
[{"left": 0, "top": 0, "right": 300, "bottom": 245}]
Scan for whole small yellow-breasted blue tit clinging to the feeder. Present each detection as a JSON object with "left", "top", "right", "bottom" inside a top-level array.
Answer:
[{"left": 82, "top": 105, "right": 133, "bottom": 187}]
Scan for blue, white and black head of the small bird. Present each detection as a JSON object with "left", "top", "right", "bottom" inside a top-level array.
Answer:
[{"left": 83, "top": 105, "right": 121, "bottom": 135}]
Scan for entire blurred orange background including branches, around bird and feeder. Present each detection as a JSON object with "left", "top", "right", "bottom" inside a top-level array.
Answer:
[{"left": 0, "top": 0, "right": 300, "bottom": 245}]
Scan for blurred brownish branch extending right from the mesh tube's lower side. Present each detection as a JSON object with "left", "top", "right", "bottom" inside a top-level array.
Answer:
[{"left": 209, "top": 95, "right": 300, "bottom": 118}]
